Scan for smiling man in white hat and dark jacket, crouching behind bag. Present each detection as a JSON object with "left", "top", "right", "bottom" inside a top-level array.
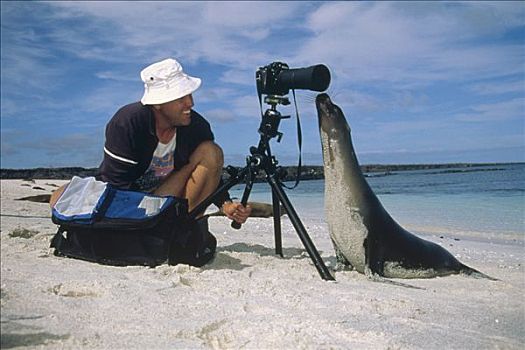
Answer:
[{"left": 50, "top": 58, "right": 251, "bottom": 266}]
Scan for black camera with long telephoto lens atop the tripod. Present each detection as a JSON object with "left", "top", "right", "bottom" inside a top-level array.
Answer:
[{"left": 255, "top": 62, "right": 330, "bottom": 96}]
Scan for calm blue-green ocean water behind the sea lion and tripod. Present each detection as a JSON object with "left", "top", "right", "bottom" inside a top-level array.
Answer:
[{"left": 230, "top": 164, "right": 525, "bottom": 240}]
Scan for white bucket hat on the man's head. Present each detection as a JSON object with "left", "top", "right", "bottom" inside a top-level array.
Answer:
[{"left": 140, "top": 58, "right": 201, "bottom": 105}]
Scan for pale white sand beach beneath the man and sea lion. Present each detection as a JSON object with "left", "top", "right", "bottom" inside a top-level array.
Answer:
[{"left": 0, "top": 180, "right": 525, "bottom": 349}]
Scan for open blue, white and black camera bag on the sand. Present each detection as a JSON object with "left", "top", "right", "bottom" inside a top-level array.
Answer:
[{"left": 51, "top": 176, "right": 189, "bottom": 266}]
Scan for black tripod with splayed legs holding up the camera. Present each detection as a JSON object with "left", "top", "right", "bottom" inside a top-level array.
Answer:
[{"left": 189, "top": 95, "right": 335, "bottom": 281}]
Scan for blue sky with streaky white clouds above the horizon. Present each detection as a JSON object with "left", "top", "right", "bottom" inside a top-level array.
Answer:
[{"left": 1, "top": 1, "right": 525, "bottom": 168}]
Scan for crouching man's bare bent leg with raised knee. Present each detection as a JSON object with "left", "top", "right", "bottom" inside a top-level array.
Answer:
[{"left": 154, "top": 141, "right": 224, "bottom": 211}]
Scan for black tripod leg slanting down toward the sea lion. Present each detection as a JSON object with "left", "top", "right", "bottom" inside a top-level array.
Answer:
[{"left": 266, "top": 173, "right": 335, "bottom": 281}]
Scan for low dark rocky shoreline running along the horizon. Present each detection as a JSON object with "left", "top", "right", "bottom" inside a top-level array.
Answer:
[{"left": 0, "top": 163, "right": 512, "bottom": 181}]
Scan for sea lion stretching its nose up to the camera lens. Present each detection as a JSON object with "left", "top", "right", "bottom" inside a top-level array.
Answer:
[{"left": 316, "top": 94, "right": 492, "bottom": 279}]
